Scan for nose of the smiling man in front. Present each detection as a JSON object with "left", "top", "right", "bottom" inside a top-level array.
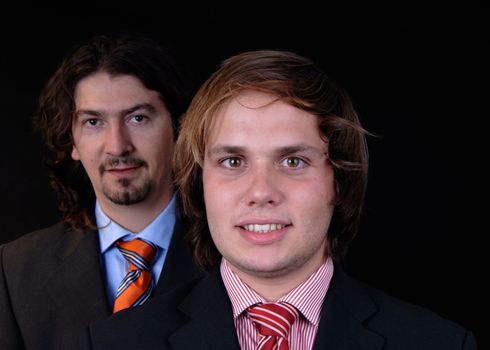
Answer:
[{"left": 246, "top": 165, "right": 283, "bottom": 207}]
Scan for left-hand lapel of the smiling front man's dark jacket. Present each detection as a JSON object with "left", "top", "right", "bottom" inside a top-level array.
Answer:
[{"left": 169, "top": 269, "right": 240, "bottom": 350}]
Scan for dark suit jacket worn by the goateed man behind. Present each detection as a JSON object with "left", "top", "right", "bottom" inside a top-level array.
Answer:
[{"left": 0, "top": 220, "right": 201, "bottom": 350}]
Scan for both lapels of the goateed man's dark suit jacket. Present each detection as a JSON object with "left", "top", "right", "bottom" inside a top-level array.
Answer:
[{"left": 45, "top": 217, "right": 202, "bottom": 332}]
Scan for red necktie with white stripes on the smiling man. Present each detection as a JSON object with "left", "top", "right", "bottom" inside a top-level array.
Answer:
[{"left": 248, "top": 302, "right": 299, "bottom": 350}]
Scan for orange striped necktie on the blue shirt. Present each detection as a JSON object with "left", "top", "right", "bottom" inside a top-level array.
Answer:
[{"left": 114, "top": 238, "right": 158, "bottom": 312}]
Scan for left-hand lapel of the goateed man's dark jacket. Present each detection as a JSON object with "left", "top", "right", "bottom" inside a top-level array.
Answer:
[{"left": 46, "top": 230, "right": 111, "bottom": 325}]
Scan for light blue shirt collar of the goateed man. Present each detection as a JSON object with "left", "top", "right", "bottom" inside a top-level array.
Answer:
[{"left": 95, "top": 194, "right": 176, "bottom": 253}]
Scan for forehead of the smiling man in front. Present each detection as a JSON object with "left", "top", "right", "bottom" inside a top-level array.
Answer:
[{"left": 207, "top": 90, "right": 324, "bottom": 145}]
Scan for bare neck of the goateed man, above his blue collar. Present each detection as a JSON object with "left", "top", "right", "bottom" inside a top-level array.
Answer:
[{"left": 99, "top": 195, "right": 171, "bottom": 233}]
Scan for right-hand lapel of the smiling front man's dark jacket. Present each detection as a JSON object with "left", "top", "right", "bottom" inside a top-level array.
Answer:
[{"left": 314, "top": 264, "right": 384, "bottom": 350}]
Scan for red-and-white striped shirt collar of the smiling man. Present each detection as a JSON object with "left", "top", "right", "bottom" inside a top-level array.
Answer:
[{"left": 220, "top": 257, "right": 334, "bottom": 326}]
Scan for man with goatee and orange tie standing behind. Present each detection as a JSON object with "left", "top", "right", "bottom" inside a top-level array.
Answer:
[{"left": 0, "top": 35, "right": 199, "bottom": 349}]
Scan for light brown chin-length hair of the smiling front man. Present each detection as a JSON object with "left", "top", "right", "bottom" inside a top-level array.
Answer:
[{"left": 174, "top": 50, "right": 368, "bottom": 267}]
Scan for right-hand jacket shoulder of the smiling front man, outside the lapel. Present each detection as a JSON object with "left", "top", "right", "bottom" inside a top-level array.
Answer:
[{"left": 332, "top": 266, "right": 476, "bottom": 349}]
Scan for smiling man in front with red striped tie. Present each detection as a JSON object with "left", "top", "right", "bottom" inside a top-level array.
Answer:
[{"left": 83, "top": 50, "right": 476, "bottom": 350}]
